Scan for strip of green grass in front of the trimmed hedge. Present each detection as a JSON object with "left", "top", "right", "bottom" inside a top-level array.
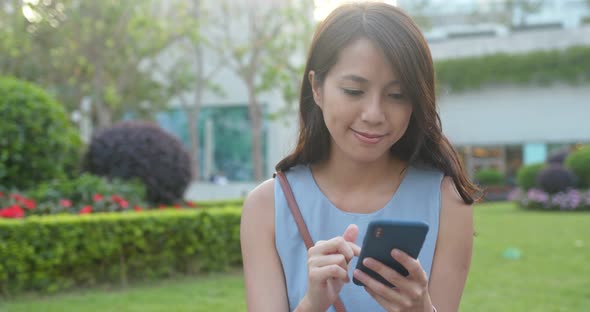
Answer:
[{"left": 0, "top": 272, "right": 246, "bottom": 312}]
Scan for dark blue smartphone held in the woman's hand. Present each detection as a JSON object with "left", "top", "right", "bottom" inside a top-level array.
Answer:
[{"left": 353, "top": 220, "right": 428, "bottom": 287}]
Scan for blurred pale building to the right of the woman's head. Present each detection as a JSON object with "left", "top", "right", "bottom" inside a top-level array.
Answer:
[{"left": 399, "top": 0, "right": 590, "bottom": 180}]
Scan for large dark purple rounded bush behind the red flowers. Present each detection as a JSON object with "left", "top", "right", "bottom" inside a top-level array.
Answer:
[{"left": 84, "top": 121, "right": 191, "bottom": 204}]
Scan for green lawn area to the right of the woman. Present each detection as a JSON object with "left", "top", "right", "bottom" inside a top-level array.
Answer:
[{"left": 461, "top": 203, "right": 590, "bottom": 311}]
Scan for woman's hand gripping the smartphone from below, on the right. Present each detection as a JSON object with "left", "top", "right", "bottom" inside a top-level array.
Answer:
[{"left": 354, "top": 249, "right": 433, "bottom": 312}]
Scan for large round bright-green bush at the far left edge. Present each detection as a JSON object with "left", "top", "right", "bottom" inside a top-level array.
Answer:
[{"left": 0, "top": 77, "right": 82, "bottom": 189}]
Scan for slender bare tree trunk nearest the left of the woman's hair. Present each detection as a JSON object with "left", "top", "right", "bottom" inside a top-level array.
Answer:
[{"left": 246, "top": 79, "right": 264, "bottom": 181}]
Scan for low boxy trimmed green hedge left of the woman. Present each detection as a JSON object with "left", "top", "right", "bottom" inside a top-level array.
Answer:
[{"left": 0, "top": 207, "right": 241, "bottom": 295}]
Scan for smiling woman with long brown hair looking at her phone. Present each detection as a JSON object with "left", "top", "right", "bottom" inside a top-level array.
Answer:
[{"left": 241, "top": 3, "right": 477, "bottom": 312}]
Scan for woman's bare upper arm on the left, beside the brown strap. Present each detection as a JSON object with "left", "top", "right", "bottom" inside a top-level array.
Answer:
[{"left": 240, "top": 180, "right": 289, "bottom": 312}]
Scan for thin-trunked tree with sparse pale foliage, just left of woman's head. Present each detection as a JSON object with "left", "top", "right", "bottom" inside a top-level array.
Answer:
[{"left": 213, "top": 0, "right": 313, "bottom": 180}]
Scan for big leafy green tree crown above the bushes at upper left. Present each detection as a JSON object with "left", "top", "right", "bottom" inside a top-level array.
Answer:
[{"left": 4, "top": 0, "right": 176, "bottom": 127}]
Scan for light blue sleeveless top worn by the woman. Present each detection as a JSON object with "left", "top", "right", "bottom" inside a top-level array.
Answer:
[{"left": 274, "top": 165, "right": 443, "bottom": 312}]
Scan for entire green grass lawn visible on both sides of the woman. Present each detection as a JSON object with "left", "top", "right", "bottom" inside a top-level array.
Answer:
[{"left": 0, "top": 203, "right": 590, "bottom": 312}]
